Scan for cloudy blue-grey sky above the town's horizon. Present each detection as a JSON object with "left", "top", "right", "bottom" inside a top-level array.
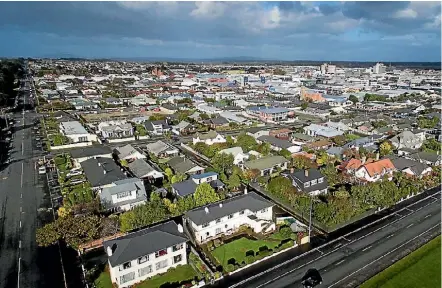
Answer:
[{"left": 0, "top": 1, "right": 441, "bottom": 62}]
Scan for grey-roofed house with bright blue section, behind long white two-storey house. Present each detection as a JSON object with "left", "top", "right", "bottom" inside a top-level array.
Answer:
[{"left": 172, "top": 172, "right": 224, "bottom": 197}]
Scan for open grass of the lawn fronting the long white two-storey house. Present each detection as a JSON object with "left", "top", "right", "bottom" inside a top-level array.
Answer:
[{"left": 212, "top": 237, "right": 281, "bottom": 267}]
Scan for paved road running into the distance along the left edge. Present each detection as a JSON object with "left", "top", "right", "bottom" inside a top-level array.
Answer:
[{"left": 0, "top": 77, "right": 62, "bottom": 288}]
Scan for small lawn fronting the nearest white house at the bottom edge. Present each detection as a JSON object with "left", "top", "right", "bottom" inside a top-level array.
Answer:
[{"left": 135, "top": 265, "right": 197, "bottom": 288}]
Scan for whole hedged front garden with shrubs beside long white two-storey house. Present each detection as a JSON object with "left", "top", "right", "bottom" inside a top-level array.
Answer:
[{"left": 208, "top": 227, "right": 296, "bottom": 272}]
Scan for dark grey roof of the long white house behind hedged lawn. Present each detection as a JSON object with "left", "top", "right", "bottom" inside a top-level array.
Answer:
[{"left": 185, "top": 192, "right": 275, "bottom": 225}]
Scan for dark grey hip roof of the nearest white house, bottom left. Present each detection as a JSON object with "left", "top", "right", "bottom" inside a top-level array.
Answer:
[{"left": 103, "top": 221, "right": 187, "bottom": 267}]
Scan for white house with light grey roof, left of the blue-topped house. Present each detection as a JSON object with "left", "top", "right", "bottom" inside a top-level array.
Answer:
[{"left": 98, "top": 178, "right": 147, "bottom": 212}]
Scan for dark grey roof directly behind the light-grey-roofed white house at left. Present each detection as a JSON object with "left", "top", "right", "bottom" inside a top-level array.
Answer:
[{"left": 80, "top": 157, "right": 127, "bottom": 187}]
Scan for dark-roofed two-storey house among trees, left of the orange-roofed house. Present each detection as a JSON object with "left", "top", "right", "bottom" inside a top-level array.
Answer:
[{"left": 281, "top": 168, "right": 328, "bottom": 196}]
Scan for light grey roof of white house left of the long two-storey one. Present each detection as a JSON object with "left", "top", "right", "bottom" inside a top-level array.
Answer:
[{"left": 100, "top": 178, "right": 147, "bottom": 209}]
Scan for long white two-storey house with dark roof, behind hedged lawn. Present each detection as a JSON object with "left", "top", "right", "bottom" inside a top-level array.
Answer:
[{"left": 183, "top": 192, "right": 276, "bottom": 243}]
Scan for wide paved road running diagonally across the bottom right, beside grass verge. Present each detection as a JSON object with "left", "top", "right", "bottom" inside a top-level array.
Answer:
[{"left": 230, "top": 193, "right": 441, "bottom": 288}]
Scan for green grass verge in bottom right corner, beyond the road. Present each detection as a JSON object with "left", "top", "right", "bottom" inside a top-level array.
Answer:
[{"left": 361, "top": 236, "right": 441, "bottom": 288}]
